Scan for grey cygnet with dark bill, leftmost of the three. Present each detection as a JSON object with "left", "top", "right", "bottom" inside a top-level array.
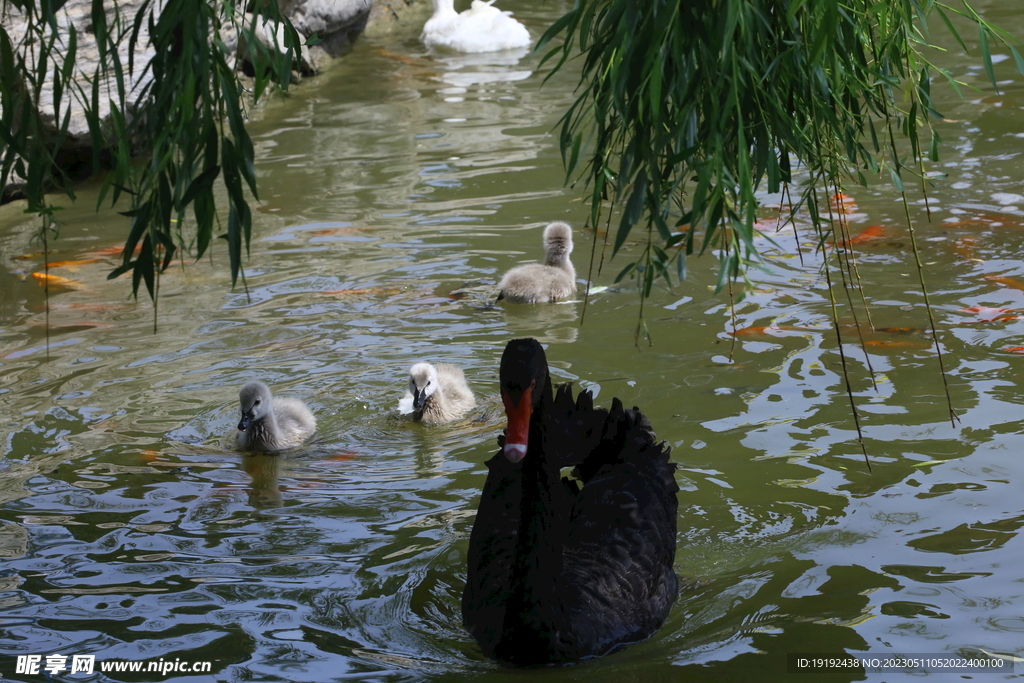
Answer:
[{"left": 234, "top": 382, "right": 316, "bottom": 451}]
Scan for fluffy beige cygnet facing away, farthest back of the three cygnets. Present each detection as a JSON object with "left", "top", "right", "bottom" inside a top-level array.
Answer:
[{"left": 498, "top": 222, "right": 575, "bottom": 303}]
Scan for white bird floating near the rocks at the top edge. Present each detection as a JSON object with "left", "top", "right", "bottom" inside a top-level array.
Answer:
[{"left": 420, "top": 0, "right": 531, "bottom": 52}]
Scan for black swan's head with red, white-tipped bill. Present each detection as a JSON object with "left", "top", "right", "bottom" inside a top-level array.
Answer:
[{"left": 498, "top": 339, "right": 548, "bottom": 463}]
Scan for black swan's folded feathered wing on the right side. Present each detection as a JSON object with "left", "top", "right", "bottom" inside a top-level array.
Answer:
[{"left": 560, "top": 399, "right": 679, "bottom": 647}]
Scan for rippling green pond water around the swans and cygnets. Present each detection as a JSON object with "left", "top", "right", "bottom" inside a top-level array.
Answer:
[{"left": 0, "top": 0, "right": 1024, "bottom": 683}]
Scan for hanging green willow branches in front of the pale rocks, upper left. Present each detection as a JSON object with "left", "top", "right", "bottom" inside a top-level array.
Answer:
[{"left": 0, "top": 0, "right": 300, "bottom": 302}]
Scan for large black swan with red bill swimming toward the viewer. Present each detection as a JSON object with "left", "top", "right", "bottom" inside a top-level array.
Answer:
[{"left": 462, "top": 339, "right": 679, "bottom": 665}]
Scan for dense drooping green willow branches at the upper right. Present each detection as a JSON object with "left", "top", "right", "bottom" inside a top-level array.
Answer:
[{"left": 538, "top": 0, "right": 1024, "bottom": 296}]
